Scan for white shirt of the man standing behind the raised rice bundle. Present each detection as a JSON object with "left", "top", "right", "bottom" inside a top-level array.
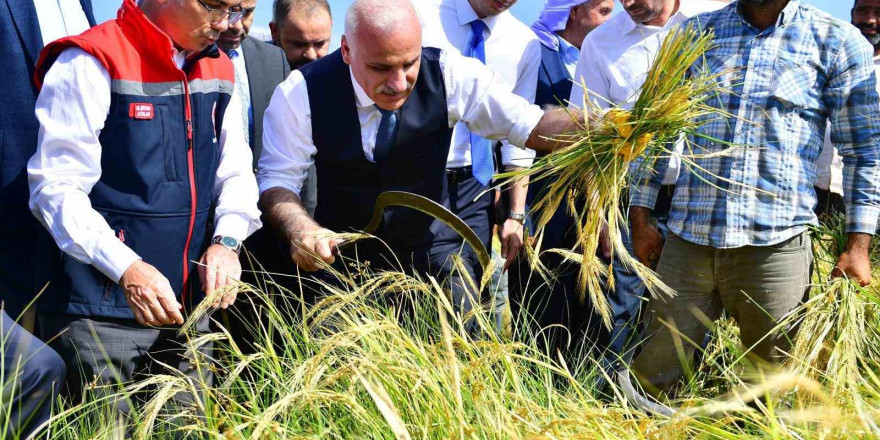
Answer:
[{"left": 569, "top": 0, "right": 725, "bottom": 185}]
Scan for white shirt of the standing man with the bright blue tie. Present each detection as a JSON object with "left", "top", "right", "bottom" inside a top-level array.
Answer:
[{"left": 415, "top": 0, "right": 541, "bottom": 168}]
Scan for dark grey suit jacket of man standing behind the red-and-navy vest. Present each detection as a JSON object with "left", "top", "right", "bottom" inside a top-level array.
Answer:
[{"left": 241, "top": 38, "right": 290, "bottom": 170}]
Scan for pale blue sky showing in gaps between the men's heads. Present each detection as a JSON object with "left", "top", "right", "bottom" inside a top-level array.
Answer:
[{"left": 92, "top": 0, "right": 852, "bottom": 48}]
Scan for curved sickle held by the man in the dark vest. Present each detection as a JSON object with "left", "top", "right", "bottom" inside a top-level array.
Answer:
[{"left": 341, "top": 191, "right": 491, "bottom": 270}]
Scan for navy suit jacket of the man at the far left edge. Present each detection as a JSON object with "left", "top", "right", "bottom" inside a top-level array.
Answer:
[{"left": 0, "top": 0, "right": 95, "bottom": 317}]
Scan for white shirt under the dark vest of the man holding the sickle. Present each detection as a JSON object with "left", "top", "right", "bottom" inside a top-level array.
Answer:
[{"left": 257, "top": 50, "right": 544, "bottom": 194}]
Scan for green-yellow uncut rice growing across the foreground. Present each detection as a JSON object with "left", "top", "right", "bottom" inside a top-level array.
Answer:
[{"left": 20, "top": 232, "right": 880, "bottom": 440}]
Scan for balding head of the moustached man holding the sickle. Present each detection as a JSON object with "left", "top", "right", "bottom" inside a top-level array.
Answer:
[{"left": 342, "top": 0, "right": 422, "bottom": 110}]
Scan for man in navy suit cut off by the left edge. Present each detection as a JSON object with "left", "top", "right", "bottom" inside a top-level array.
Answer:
[{"left": 0, "top": 0, "right": 95, "bottom": 438}]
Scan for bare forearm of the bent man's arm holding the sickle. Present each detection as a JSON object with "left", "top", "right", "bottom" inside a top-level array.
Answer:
[{"left": 260, "top": 187, "right": 320, "bottom": 242}]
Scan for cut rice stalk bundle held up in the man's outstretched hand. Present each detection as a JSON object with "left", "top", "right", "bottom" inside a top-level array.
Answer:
[{"left": 501, "top": 26, "right": 730, "bottom": 327}]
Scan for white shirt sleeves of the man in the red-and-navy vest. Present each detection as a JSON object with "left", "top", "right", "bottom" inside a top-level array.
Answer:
[{"left": 28, "top": 48, "right": 261, "bottom": 282}]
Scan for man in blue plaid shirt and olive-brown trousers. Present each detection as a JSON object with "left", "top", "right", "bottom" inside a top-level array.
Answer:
[{"left": 630, "top": 0, "right": 880, "bottom": 392}]
